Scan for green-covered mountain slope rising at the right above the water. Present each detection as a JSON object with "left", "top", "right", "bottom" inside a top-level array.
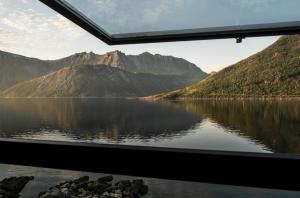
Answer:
[{"left": 150, "top": 35, "right": 300, "bottom": 99}]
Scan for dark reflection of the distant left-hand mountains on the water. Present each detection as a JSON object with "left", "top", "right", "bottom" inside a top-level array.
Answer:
[{"left": 0, "top": 99, "right": 200, "bottom": 141}]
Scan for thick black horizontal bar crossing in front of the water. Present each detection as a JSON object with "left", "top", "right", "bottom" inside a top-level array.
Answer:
[{"left": 0, "top": 139, "right": 300, "bottom": 191}]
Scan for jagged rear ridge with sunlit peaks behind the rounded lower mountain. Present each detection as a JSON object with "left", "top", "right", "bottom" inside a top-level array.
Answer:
[{"left": 50, "top": 50, "right": 207, "bottom": 83}]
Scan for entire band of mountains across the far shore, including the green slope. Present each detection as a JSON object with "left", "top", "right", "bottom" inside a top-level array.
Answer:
[{"left": 0, "top": 35, "right": 300, "bottom": 99}]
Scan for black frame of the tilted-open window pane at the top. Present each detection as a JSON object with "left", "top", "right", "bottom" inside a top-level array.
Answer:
[{"left": 40, "top": 0, "right": 300, "bottom": 45}]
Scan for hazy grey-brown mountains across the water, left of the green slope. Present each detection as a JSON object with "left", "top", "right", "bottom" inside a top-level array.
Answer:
[{"left": 0, "top": 51, "right": 207, "bottom": 97}]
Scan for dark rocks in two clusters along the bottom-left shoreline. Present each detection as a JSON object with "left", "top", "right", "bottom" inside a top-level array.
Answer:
[{"left": 0, "top": 176, "right": 148, "bottom": 198}]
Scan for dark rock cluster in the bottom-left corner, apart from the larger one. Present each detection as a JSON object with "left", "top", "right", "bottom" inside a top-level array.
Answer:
[{"left": 0, "top": 176, "right": 34, "bottom": 198}]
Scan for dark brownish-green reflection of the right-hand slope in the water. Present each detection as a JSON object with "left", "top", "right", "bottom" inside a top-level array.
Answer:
[{"left": 166, "top": 100, "right": 300, "bottom": 153}]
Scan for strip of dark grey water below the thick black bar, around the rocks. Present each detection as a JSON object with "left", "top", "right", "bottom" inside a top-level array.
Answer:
[{"left": 0, "top": 164, "right": 300, "bottom": 198}]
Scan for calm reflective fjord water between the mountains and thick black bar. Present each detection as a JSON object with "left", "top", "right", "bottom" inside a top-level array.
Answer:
[{"left": 0, "top": 98, "right": 300, "bottom": 153}]
